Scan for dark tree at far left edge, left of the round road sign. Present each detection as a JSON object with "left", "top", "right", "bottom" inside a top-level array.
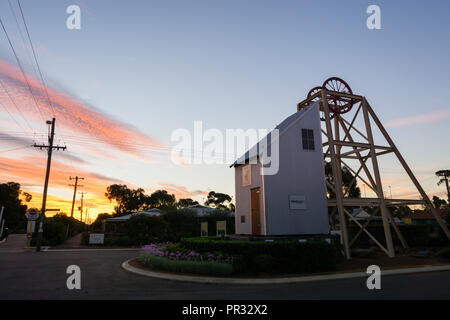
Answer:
[{"left": 0, "top": 182, "right": 31, "bottom": 232}]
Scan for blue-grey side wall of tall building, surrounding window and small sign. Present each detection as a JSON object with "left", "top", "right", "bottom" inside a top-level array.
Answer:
[{"left": 263, "top": 105, "right": 329, "bottom": 235}]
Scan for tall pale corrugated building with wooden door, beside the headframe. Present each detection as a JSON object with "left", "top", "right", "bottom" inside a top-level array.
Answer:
[{"left": 232, "top": 103, "right": 329, "bottom": 235}]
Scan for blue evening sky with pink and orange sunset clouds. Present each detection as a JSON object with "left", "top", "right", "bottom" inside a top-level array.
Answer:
[{"left": 0, "top": 0, "right": 450, "bottom": 217}]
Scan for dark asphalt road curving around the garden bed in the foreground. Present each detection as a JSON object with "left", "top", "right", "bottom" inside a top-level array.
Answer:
[{"left": 0, "top": 249, "right": 450, "bottom": 300}]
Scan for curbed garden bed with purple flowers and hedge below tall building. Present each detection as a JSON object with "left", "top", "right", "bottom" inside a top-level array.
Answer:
[{"left": 130, "top": 238, "right": 450, "bottom": 278}]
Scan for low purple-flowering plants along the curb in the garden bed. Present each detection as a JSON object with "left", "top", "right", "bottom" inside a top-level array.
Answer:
[{"left": 139, "top": 253, "right": 233, "bottom": 275}]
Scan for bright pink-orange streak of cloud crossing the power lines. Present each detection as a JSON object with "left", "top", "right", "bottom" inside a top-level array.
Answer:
[{"left": 0, "top": 60, "right": 168, "bottom": 159}]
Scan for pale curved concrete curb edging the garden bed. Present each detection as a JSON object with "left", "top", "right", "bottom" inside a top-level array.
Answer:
[{"left": 122, "top": 258, "right": 450, "bottom": 284}]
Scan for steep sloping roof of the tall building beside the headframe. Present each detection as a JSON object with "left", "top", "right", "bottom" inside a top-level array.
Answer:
[{"left": 230, "top": 102, "right": 319, "bottom": 168}]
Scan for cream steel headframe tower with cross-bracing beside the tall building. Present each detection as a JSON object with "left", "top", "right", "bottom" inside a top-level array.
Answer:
[{"left": 297, "top": 88, "right": 450, "bottom": 259}]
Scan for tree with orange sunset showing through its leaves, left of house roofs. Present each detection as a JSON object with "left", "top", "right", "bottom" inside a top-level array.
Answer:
[{"left": 105, "top": 184, "right": 149, "bottom": 215}]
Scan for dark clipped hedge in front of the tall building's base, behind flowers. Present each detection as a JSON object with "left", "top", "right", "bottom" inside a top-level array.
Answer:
[{"left": 181, "top": 237, "right": 337, "bottom": 273}]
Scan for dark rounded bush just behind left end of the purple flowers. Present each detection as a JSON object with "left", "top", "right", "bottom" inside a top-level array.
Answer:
[{"left": 125, "top": 215, "right": 167, "bottom": 245}]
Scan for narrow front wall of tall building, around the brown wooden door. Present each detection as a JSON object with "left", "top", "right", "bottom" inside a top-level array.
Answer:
[{"left": 234, "top": 163, "right": 265, "bottom": 234}]
